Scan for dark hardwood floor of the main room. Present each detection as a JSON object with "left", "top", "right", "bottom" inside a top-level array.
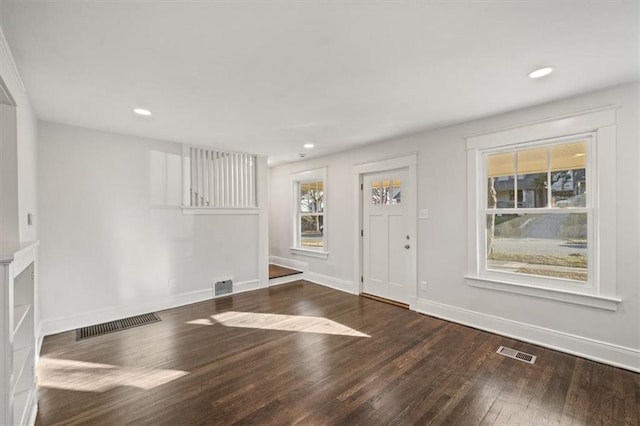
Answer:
[{"left": 37, "top": 281, "right": 640, "bottom": 425}]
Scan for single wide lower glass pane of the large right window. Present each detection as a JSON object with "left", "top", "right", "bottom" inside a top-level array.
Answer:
[{"left": 487, "top": 213, "right": 588, "bottom": 281}]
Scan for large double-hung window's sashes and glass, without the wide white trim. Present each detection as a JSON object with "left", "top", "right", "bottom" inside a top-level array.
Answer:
[{"left": 488, "top": 134, "right": 595, "bottom": 287}]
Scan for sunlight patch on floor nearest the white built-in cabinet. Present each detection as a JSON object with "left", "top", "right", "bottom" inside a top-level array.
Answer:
[{"left": 38, "top": 357, "right": 189, "bottom": 392}]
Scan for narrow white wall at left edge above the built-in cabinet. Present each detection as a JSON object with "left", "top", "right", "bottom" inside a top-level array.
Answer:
[{"left": 0, "top": 28, "right": 38, "bottom": 242}]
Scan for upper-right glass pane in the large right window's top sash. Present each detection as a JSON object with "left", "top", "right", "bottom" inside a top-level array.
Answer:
[{"left": 551, "top": 141, "right": 587, "bottom": 207}]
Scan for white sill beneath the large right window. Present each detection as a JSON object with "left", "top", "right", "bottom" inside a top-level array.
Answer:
[{"left": 465, "top": 275, "right": 622, "bottom": 311}]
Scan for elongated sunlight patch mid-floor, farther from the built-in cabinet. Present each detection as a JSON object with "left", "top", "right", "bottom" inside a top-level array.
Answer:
[{"left": 187, "top": 311, "right": 371, "bottom": 337}]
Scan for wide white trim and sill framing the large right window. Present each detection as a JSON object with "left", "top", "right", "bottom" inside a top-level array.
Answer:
[{"left": 465, "top": 106, "right": 621, "bottom": 310}]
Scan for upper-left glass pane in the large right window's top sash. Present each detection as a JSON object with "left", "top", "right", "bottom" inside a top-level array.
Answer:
[{"left": 487, "top": 152, "right": 516, "bottom": 209}]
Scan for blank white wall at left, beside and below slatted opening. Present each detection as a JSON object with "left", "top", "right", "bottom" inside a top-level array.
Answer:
[{"left": 38, "top": 122, "right": 267, "bottom": 334}]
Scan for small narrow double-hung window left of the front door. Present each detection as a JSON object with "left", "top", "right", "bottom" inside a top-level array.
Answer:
[{"left": 291, "top": 168, "right": 327, "bottom": 257}]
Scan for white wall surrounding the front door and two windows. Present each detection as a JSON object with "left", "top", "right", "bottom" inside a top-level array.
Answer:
[{"left": 270, "top": 84, "right": 640, "bottom": 371}]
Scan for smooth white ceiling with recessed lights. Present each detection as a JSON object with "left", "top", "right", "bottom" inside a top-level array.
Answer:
[{"left": 0, "top": 0, "right": 639, "bottom": 164}]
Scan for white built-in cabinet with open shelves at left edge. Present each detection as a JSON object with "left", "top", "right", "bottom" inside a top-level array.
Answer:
[{"left": 0, "top": 243, "right": 38, "bottom": 425}]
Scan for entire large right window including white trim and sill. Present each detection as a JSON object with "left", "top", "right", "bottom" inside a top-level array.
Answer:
[{"left": 466, "top": 107, "right": 620, "bottom": 310}]
